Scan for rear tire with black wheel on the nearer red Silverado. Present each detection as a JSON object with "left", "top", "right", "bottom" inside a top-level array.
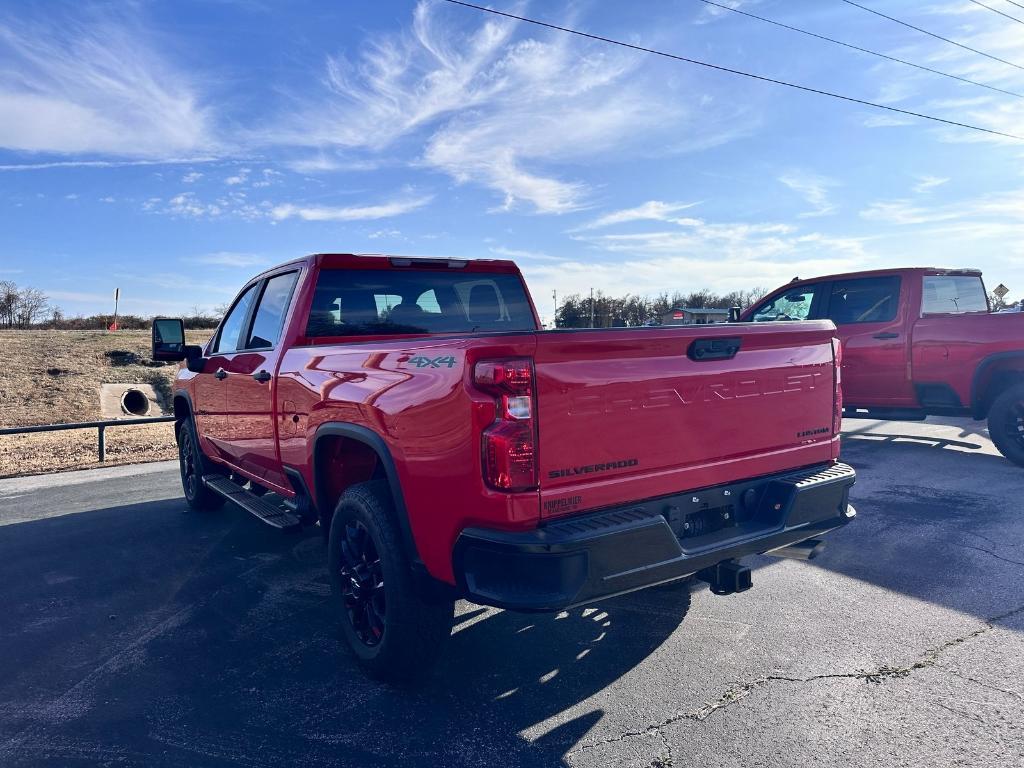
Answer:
[{"left": 328, "top": 480, "right": 455, "bottom": 685}]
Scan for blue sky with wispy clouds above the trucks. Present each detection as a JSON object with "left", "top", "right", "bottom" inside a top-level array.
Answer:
[{"left": 0, "top": 0, "right": 1024, "bottom": 325}]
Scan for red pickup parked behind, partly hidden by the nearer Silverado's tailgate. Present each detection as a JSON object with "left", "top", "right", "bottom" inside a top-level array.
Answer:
[{"left": 740, "top": 268, "right": 1024, "bottom": 466}]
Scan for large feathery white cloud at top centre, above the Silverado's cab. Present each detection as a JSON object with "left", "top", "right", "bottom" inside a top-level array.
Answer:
[{"left": 278, "top": 2, "right": 721, "bottom": 214}]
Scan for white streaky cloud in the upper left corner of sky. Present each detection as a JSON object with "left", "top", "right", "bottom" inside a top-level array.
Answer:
[{"left": 0, "top": 12, "right": 216, "bottom": 159}]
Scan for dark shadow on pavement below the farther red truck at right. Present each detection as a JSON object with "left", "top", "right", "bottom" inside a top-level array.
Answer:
[{"left": 811, "top": 434, "right": 1024, "bottom": 618}]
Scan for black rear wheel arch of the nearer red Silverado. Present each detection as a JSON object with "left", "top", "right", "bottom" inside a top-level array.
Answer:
[{"left": 312, "top": 422, "right": 422, "bottom": 567}]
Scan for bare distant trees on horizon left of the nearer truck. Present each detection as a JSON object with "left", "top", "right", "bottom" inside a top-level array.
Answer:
[{"left": 0, "top": 280, "right": 226, "bottom": 331}]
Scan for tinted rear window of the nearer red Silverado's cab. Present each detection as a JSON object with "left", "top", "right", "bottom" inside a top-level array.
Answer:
[{"left": 306, "top": 269, "right": 537, "bottom": 337}]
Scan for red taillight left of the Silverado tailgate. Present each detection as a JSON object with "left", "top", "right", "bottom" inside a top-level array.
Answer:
[{"left": 473, "top": 357, "right": 537, "bottom": 490}]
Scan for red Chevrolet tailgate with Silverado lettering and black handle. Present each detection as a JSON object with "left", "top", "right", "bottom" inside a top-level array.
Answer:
[{"left": 535, "top": 321, "right": 839, "bottom": 517}]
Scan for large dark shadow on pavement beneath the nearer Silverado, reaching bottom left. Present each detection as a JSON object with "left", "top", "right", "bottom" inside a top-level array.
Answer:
[{"left": 0, "top": 500, "right": 689, "bottom": 767}]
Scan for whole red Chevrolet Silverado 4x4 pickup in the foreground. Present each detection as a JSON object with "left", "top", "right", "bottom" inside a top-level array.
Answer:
[{"left": 154, "top": 254, "right": 855, "bottom": 681}]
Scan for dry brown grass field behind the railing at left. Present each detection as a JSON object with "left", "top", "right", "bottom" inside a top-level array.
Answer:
[{"left": 0, "top": 331, "right": 211, "bottom": 477}]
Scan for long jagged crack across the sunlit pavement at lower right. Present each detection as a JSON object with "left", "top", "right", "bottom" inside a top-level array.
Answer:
[{"left": 570, "top": 605, "right": 1024, "bottom": 765}]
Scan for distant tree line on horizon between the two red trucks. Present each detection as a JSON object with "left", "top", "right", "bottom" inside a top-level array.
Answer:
[{"left": 555, "top": 288, "right": 768, "bottom": 328}]
